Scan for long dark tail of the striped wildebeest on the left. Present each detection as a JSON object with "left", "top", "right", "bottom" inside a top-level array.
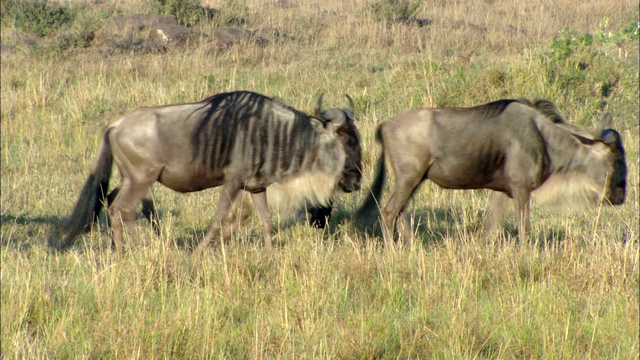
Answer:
[{"left": 62, "top": 129, "right": 113, "bottom": 247}]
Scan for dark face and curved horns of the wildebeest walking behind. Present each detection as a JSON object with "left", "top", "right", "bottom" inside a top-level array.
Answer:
[{"left": 315, "top": 94, "right": 362, "bottom": 193}]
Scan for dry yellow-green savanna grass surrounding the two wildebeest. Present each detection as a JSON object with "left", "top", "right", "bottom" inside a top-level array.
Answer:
[{"left": 0, "top": 0, "right": 639, "bottom": 359}]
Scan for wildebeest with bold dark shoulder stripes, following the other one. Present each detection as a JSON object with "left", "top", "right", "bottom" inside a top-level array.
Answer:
[{"left": 63, "top": 91, "right": 361, "bottom": 251}]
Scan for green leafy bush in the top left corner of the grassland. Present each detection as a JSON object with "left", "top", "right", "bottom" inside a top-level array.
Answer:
[{"left": 2, "top": 0, "right": 76, "bottom": 37}]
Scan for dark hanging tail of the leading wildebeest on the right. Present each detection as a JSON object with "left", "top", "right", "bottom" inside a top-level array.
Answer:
[{"left": 355, "top": 127, "right": 386, "bottom": 229}]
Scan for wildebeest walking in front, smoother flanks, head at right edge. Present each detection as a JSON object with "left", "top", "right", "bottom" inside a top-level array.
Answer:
[{"left": 356, "top": 100, "right": 626, "bottom": 242}]
